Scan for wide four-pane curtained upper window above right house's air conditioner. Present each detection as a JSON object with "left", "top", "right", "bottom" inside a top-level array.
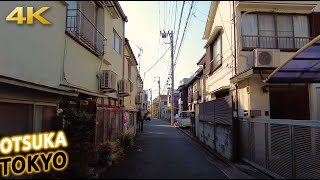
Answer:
[{"left": 241, "top": 13, "right": 310, "bottom": 50}]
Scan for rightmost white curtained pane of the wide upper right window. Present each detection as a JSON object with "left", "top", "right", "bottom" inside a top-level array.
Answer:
[{"left": 293, "top": 15, "right": 310, "bottom": 48}]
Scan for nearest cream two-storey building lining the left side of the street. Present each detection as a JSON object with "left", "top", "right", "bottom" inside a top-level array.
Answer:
[{"left": 0, "top": 1, "right": 135, "bottom": 143}]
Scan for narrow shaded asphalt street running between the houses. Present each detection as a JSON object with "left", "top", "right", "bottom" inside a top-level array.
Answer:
[{"left": 103, "top": 119, "right": 228, "bottom": 179}]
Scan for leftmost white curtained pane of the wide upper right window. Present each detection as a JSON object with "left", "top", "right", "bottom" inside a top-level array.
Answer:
[{"left": 241, "top": 14, "right": 258, "bottom": 48}]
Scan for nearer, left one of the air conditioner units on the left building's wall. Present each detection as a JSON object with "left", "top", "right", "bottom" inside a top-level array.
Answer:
[{"left": 100, "top": 70, "right": 117, "bottom": 92}]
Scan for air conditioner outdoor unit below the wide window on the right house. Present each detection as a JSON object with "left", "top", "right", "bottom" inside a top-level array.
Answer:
[{"left": 253, "top": 49, "right": 280, "bottom": 67}]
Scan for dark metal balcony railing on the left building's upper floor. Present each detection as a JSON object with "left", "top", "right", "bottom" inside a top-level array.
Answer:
[{"left": 66, "top": 9, "right": 107, "bottom": 56}]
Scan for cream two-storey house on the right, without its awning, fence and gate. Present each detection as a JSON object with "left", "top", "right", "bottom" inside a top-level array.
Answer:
[{"left": 203, "top": 1, "right": 320, "bottom": 119}]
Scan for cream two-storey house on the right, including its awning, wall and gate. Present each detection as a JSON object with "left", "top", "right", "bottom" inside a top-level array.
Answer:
[{"left": 198, "top": 1, "right": 320, "bottom": 178}]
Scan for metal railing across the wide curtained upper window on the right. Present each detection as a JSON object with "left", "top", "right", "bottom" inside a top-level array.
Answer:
[{"left": 241, "top": 35, "right": 313, "bottom": 51}]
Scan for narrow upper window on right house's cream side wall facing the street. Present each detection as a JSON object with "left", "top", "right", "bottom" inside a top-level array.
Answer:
[{"left": 210, "top": 35, "right": 222, "bottom": 73}]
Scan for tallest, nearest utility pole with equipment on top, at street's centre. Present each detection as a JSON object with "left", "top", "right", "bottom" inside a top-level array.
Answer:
[{"left": 160, "top": 31, "right": 174, "bottom": 126}]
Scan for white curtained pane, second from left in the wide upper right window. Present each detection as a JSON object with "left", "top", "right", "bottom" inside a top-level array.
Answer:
[{"left": 258, "top": 15, "right": 276, "bottom": 48}]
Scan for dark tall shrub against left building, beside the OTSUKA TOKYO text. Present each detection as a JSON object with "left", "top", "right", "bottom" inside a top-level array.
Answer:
[{"left": 63, "top": 108, "right": 95, "bottom": 178}]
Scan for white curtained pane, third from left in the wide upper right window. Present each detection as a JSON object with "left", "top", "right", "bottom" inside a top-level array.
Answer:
[{"left": 277, "top": 15, "right": 294, "bottom": 48}]
